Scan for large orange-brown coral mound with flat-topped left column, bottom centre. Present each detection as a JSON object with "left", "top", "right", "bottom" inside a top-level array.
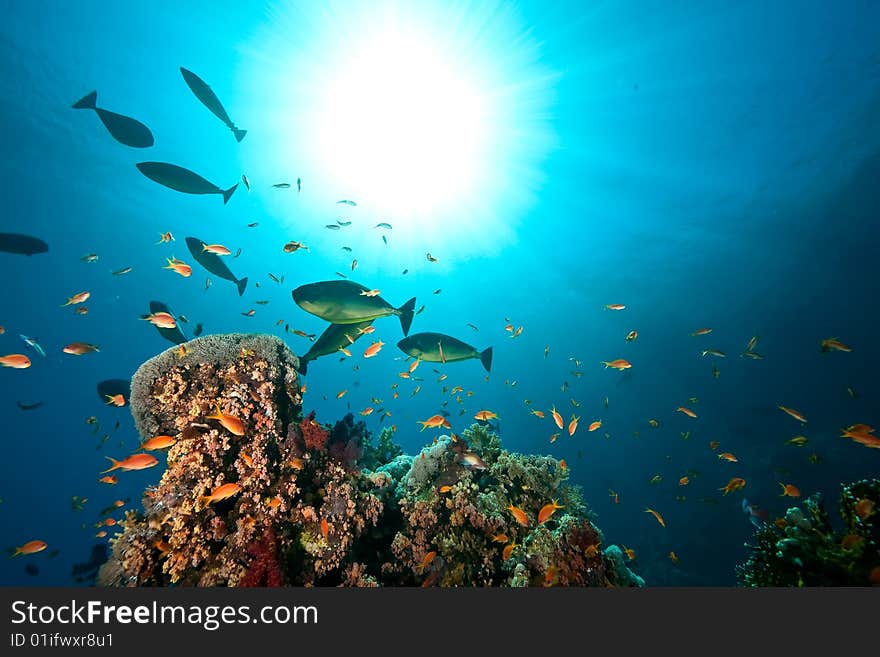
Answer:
[{"left": 99, "top": 334, "right": 642, "bottom": 586}]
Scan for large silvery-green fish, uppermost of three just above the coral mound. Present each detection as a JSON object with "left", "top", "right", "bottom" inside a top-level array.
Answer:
[{"left": 292, "top": 280, "right": 416, "bottom": 335}]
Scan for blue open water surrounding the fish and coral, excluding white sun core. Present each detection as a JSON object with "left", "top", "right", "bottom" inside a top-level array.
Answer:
[{"left": 0, "top": 2, "right": 880, "bottom": 586}]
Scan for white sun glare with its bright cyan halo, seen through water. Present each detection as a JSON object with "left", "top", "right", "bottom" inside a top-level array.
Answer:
[{"left": 242, "top": 0, "right": 558, "bottom": 266}]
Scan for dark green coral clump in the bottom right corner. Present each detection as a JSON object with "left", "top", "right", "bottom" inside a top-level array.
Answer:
[{"left": 736, "top": 479, "right": 880, "bottom": 587}]
